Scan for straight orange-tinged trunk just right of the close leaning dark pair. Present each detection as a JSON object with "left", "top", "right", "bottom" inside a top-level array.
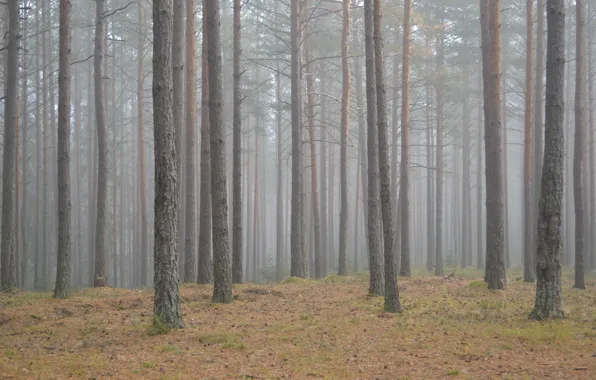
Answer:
[{"left": 398, "top": 0, "right": 412, "bottom": 277}]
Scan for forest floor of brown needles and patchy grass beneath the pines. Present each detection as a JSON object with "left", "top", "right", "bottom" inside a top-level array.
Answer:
[{"left": 0, "top": 269, "right": 596, "bottom": 379}]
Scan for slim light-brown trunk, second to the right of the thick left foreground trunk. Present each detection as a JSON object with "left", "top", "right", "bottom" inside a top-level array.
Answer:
[{"left": 184, "top": 0, "right": 198, "bottom": 282}]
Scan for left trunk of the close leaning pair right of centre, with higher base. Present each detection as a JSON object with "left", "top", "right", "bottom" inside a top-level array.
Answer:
[{"left": 364, "top": 0, "right": 384, "bottom": 296}]
